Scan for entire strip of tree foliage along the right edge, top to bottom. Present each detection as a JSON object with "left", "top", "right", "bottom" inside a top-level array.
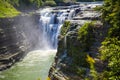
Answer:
[{"left": 100, "top": 0, "right": 120, "bottom": 80}]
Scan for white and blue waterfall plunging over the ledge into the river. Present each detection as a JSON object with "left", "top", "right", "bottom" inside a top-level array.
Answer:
[{"left": 39, "top": 8, "right": 74, "bottom": 49}]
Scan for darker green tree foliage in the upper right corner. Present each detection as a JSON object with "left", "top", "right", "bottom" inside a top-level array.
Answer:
[{"left": 102, "top": 0, "right": 120, "bottom": 38}]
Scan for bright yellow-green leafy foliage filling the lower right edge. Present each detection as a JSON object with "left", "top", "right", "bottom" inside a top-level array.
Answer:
[{"left": 100, "top": 38, "right": 120, "bottom": 80}]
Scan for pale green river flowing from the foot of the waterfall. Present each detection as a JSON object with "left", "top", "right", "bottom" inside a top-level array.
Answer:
[{"left": 0, "top": 50, "right": 56, "bottom": 80}]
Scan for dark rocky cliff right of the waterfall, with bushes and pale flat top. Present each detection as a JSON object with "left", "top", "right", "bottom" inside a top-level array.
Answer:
[{"left": 49, "top": 6, "right": 107, "bottom": 80}]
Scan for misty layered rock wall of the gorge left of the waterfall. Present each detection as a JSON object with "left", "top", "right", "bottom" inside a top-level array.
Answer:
[{"left": 0, "top": 15, "right": 39, "bottom": 70}]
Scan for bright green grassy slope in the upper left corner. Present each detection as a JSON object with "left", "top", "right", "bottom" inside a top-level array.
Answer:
[{"left": 0, "top": 0, "right": 20, "bottom": 18}]
